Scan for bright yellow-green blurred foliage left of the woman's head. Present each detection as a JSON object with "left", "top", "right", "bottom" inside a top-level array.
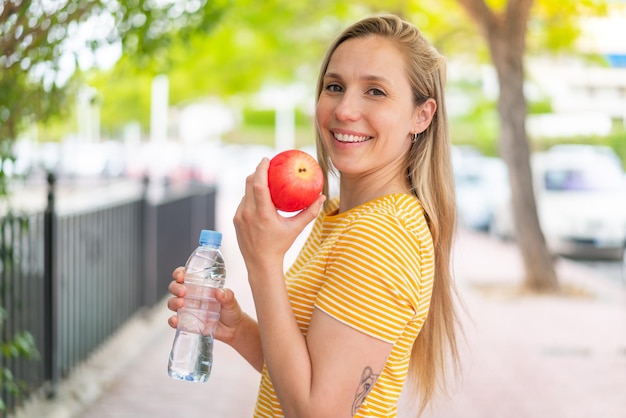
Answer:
[{"left": 84, "top": 0, "right": 359, "bottom": 133}]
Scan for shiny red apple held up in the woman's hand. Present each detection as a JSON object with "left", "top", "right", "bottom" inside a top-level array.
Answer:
[{"left": 267, "top": 150, "right": 324, "bottom": 212}]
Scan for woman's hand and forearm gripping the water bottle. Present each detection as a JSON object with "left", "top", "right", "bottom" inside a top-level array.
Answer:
[{"left": 167, "top": 267, "right": 263, "bottom": 373}]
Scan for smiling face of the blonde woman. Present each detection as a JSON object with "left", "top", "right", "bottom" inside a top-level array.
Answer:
[{"left": 316, "top": 36, "right": 420, "bottom": 181}]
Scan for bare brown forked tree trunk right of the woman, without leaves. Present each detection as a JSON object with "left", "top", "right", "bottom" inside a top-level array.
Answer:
[{"left": 459, "top": 0, "right": 558, "bottom": 291}]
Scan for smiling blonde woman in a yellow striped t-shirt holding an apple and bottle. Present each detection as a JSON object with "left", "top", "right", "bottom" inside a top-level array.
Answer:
[{"left": 168, "top": 16, "right": 458, "bottom": 418}]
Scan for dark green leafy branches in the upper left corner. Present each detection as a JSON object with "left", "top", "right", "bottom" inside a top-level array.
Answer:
[{"left": 0, "top": 0, "right": 230, "bottom": 183}]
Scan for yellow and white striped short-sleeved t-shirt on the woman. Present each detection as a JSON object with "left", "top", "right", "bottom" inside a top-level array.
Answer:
[{"left": 254, "top": 194, "right": 434, "bottom": 417}]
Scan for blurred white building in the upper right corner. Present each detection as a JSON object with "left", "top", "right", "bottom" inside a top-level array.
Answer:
[{"left": 528, "top": 0, "right": 626, "bottom": 136}]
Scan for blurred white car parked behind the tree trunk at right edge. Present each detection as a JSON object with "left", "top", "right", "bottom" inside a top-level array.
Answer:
[{"left": 490, "top": 146, "right": 626, "bottom": 260}]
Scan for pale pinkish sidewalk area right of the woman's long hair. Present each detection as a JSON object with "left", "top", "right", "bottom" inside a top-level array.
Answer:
[{"left": 416, "top": 232, "right": 626, "bottom": 418}]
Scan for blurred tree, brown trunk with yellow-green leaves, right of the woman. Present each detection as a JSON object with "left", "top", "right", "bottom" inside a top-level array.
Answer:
[{"left": 457, "top": 0, "right": 604, "bottom": 291}]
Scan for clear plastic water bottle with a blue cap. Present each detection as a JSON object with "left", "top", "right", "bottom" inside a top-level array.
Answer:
[{"left": 168, "top": 230, "right": 226, "bottom": 382}]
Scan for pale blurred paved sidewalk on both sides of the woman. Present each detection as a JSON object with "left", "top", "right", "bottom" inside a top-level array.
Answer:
[{"left": 13, "top": 188, "right": 626, "bottom": 418}]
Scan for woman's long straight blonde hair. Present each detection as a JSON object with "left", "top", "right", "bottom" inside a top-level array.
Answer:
[{"left": 316, "top": 15, "right": 459, "bottom": 415}]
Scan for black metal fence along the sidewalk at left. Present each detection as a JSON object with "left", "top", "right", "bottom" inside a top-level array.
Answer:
[{"left": 0, "top": 176, "right": 217, "bottom": 415}]
